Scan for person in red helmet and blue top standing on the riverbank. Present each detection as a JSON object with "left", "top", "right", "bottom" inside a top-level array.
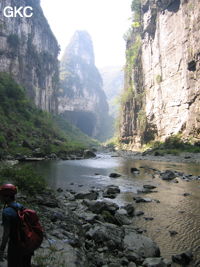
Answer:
[{"left": 0, "top": 184, "right": 32, "bottom": 267}]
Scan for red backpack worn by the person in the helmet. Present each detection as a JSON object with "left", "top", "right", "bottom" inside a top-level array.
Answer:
[{"left": 12, "top": 207, "right": 44, "bottom": 255}]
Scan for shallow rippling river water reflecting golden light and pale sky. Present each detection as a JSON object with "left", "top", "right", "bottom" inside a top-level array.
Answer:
[{"left": 28, "top": 154, "right": 200, "bottom": 266}]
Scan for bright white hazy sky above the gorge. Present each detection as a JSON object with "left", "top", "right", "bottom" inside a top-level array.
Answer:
[{"left": 41, "top": 0, "right": 132, "bottom": 67}]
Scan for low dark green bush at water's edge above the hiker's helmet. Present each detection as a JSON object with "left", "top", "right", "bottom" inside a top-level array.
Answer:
[{"left": 0, "top": 165, "right": 46, "bottom": 195}]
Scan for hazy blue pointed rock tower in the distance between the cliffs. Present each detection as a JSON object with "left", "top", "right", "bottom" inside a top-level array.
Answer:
[{"left": 58, "top": 31, "right": 108, "bottom": 139}]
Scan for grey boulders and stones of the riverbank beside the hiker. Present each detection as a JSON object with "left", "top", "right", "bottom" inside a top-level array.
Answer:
[{"left": 10, "top": 180, "right": 192, "bottom": 267}]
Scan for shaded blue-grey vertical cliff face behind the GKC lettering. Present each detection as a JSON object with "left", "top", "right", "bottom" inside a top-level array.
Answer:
[{"left": 0, "top": 0, "right": 59, "bottom": 112}]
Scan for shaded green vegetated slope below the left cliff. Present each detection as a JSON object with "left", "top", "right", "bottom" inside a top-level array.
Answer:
[{"left": 0, "top": 73, "right": 95, "bottom": 158}]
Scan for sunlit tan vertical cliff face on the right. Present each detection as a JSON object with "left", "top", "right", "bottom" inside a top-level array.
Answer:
[{"left": 121, "top": 0, "right": 200, "bottom": 147}]
